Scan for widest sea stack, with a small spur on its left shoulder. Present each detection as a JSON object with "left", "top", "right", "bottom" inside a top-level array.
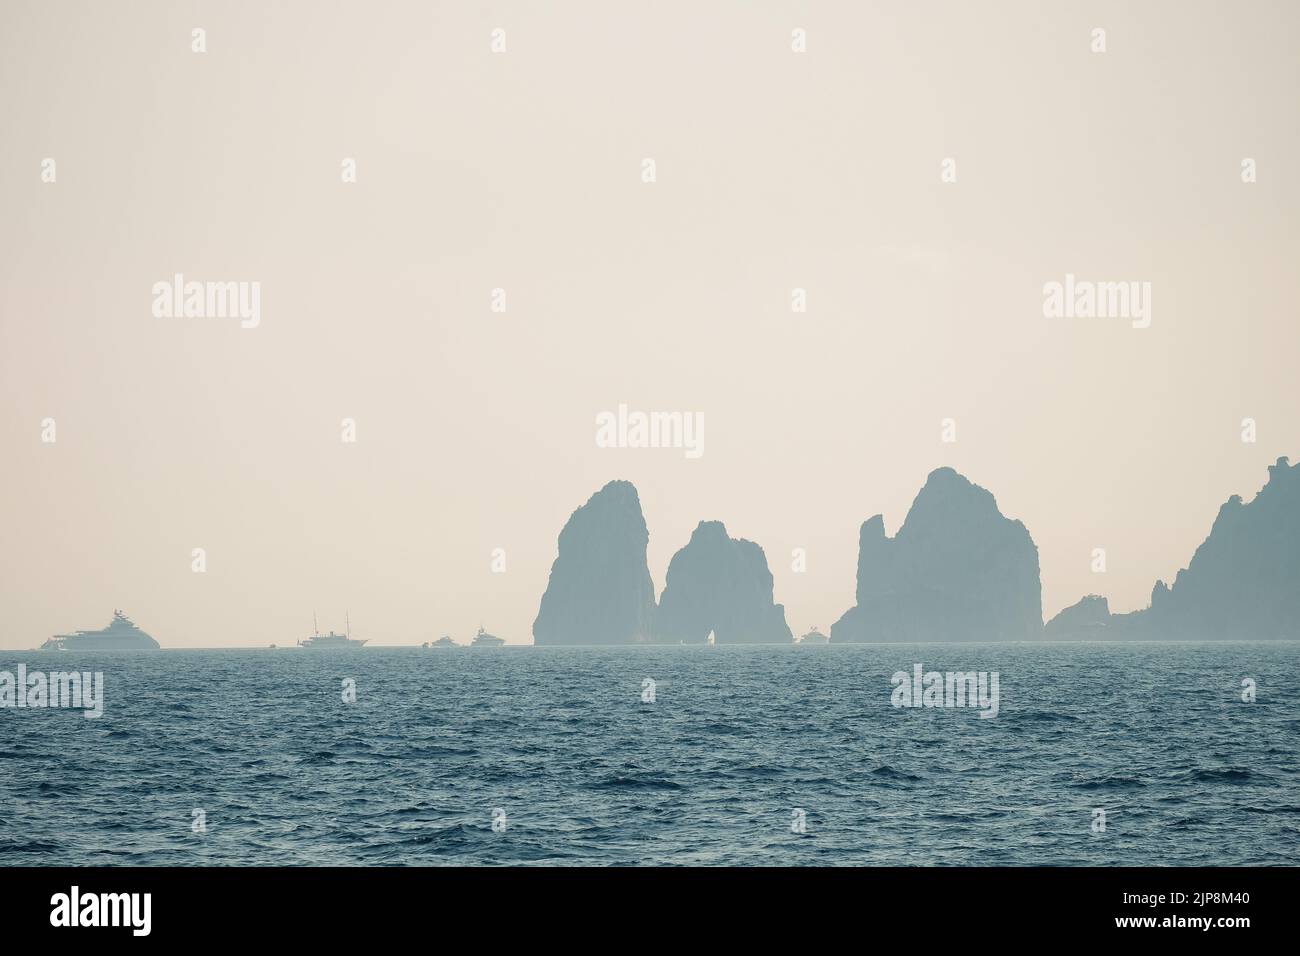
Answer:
[{"left": 831, "top": 468, "right": 1043, "bottom": 644}]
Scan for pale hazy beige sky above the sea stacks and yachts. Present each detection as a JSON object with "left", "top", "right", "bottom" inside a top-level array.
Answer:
[{"left": 0, "top": 0, "right": 1300, "bottom": 648}]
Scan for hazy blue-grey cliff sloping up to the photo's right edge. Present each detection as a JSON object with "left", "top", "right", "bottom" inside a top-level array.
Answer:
[{"left": 1049, "top": 458, "right": 1300, "bottom": 640}]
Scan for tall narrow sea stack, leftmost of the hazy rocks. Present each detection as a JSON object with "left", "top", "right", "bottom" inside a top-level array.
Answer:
[{"left": 533, "top": 481, "right": 655, "bottom": 644}]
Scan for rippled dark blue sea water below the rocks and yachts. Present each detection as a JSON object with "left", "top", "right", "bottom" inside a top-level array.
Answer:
[{"left": 0, "top": 643, "right": 1300, "bottom": 866}]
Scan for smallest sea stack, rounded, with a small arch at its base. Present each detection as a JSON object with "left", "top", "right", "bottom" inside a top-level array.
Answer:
[{"left": 655, "top": 522, "right": 794, "bottom": 644}]
